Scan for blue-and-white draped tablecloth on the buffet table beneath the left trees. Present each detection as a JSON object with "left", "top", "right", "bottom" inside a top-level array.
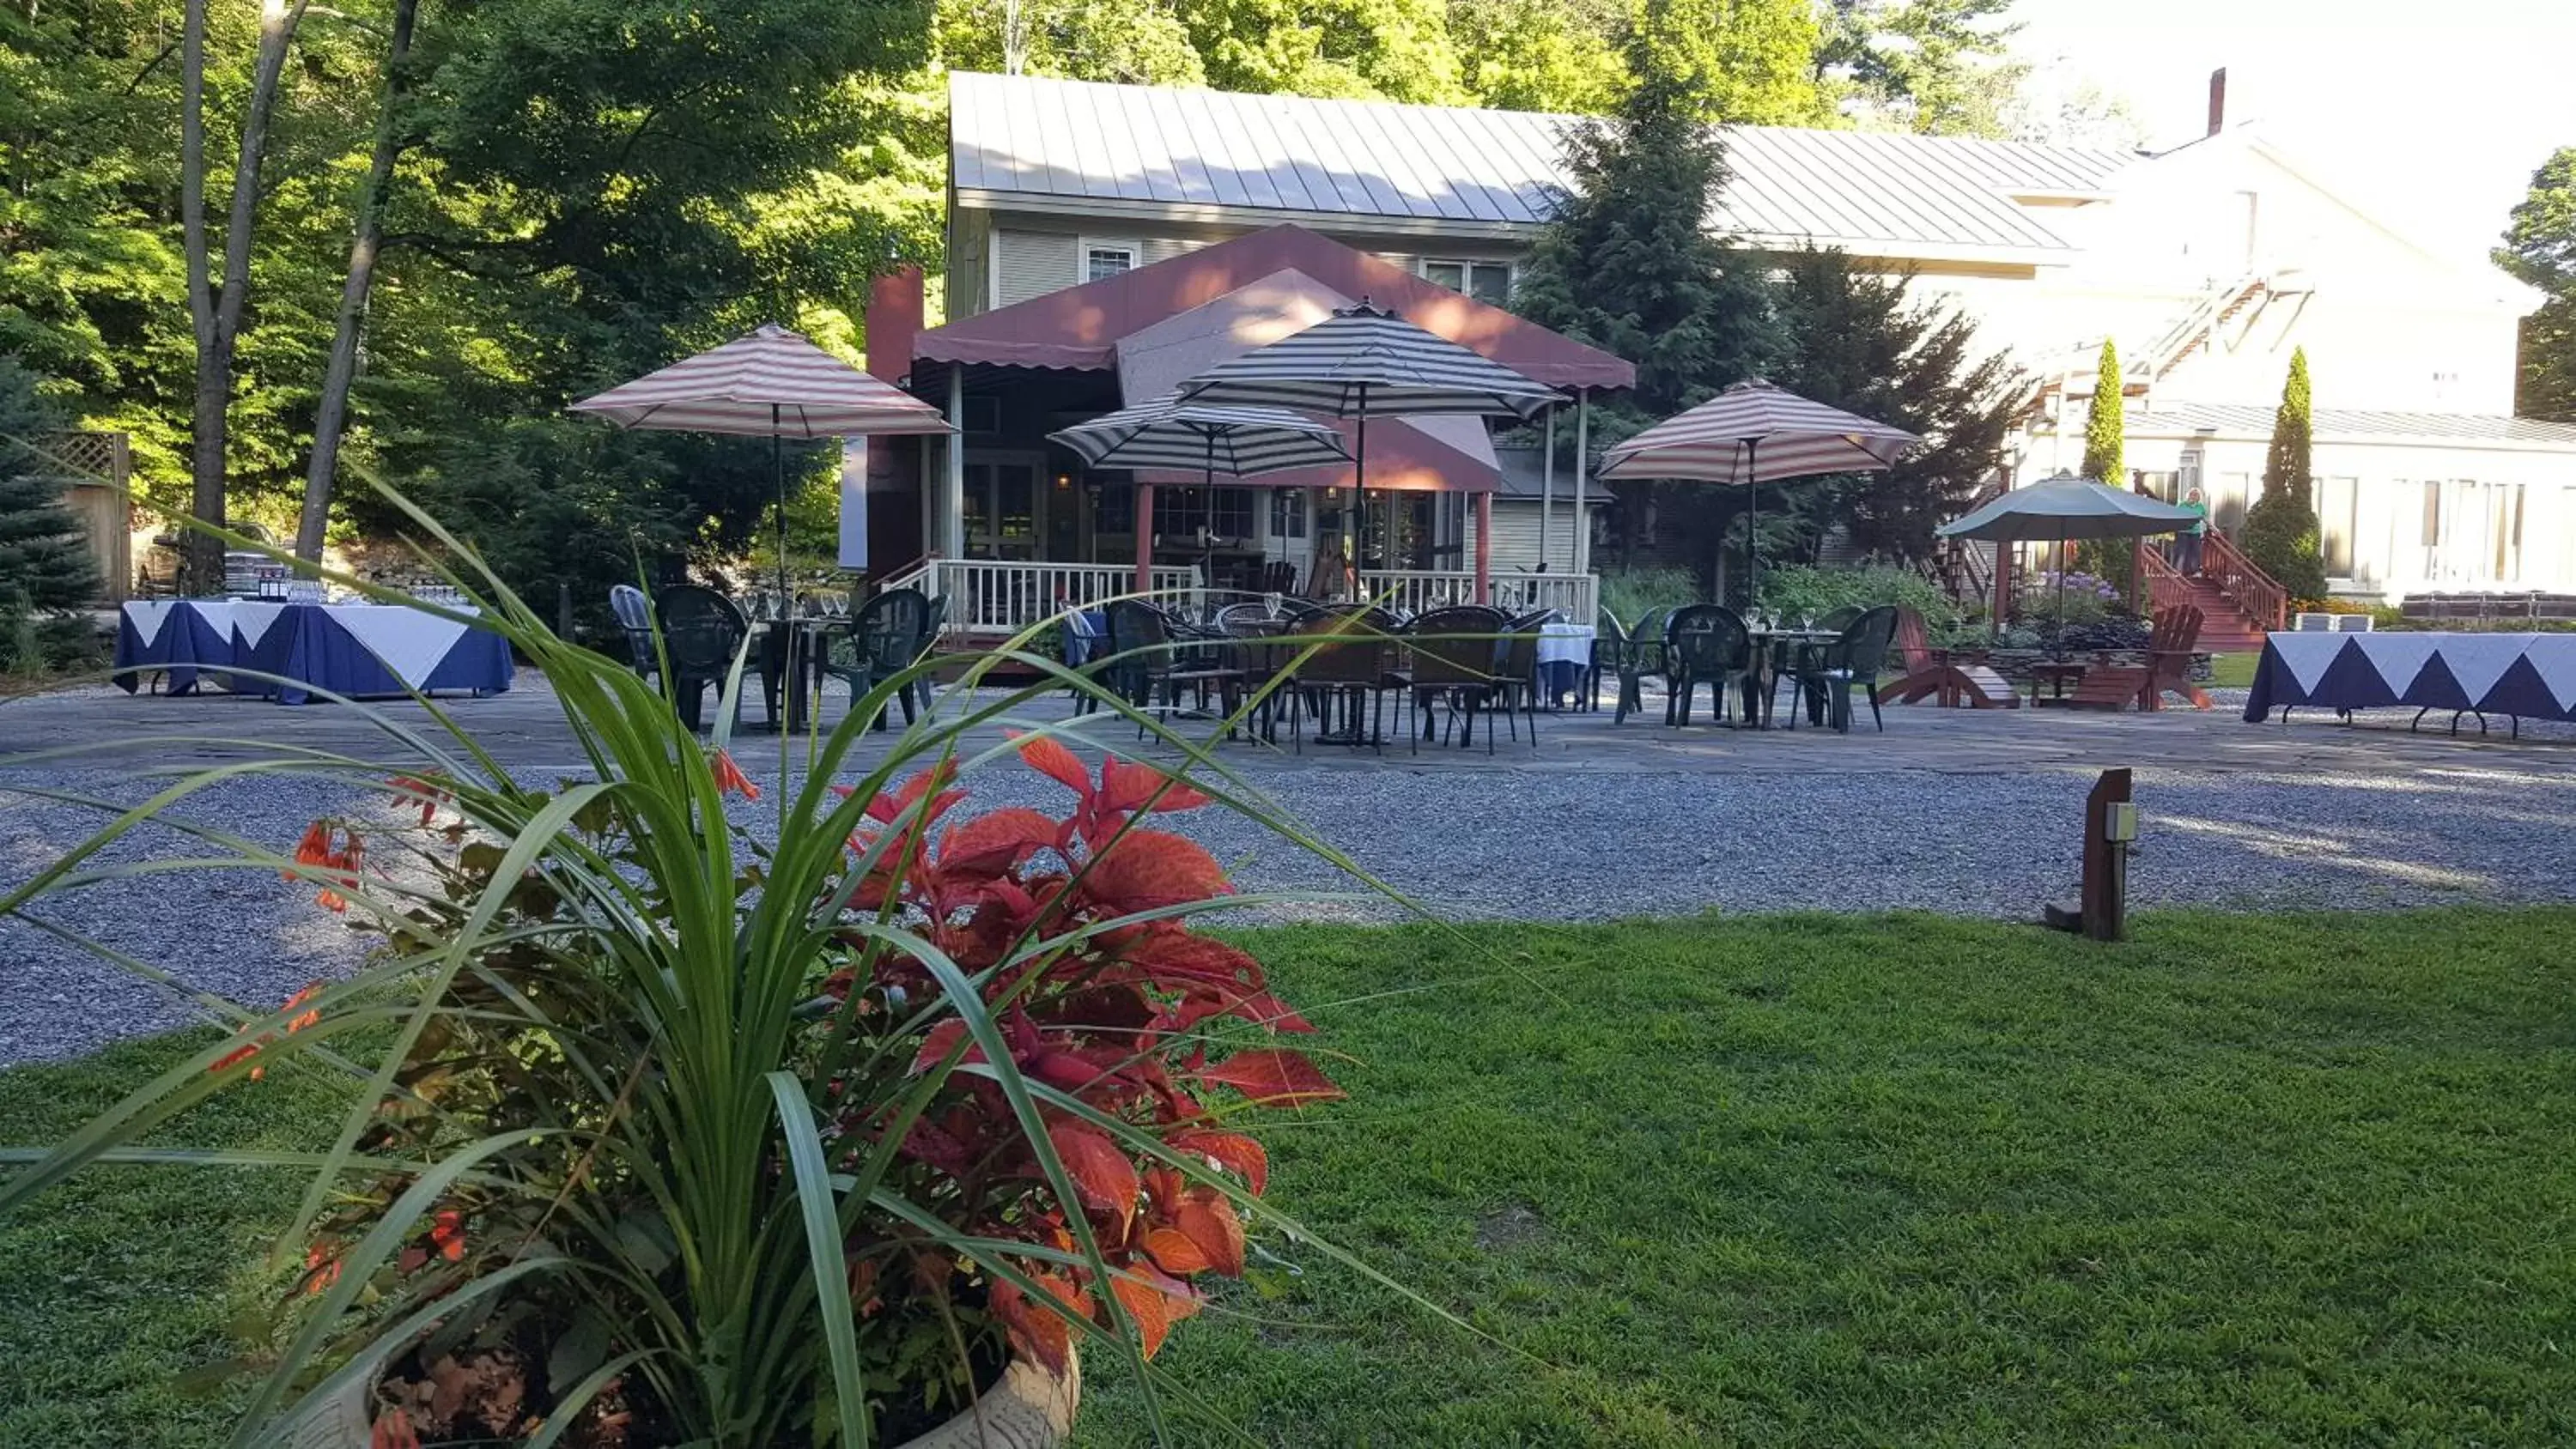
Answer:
[{"left": 116, "top": 600, "right": 513, "bottom": 706}]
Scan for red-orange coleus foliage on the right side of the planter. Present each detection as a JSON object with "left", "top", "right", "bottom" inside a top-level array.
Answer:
[{"left": 827, "top": 736, "right": 1340, "bottom": 1372}]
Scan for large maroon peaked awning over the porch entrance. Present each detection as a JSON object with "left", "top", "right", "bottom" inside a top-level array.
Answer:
[{"left": 912, "top": 227, "right": 1636, "bottom": 389}]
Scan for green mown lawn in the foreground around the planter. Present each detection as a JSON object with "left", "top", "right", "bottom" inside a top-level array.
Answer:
[{"left": 0, "top": 908, "right": 2576, "bottom": 1449}]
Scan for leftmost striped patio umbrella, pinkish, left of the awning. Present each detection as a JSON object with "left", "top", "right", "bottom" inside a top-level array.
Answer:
[{"left": 572, "top": 322, "right": 948, "bottom": 595}]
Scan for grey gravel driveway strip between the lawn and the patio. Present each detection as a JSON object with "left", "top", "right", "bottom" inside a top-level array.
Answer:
[{"left": 15, "top": 721, "right": 2576, "bottom": 1065}]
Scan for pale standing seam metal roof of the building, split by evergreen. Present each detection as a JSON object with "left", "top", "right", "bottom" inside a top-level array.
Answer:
[{"left": 948, "top": 72, "right": 2138, "bottom": 252}]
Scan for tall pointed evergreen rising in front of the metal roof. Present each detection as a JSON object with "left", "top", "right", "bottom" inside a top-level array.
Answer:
[{"left": 1512, "top": 5, "right": 1777, "bottom": 584}]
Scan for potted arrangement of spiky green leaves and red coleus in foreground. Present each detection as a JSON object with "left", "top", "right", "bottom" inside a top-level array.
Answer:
[{"left": 0, "top": 515, "right": 1340, "bottom": 1449}]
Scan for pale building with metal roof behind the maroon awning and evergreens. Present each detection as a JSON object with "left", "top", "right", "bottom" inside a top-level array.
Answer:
[{"left": 945, "top": 75, "right": 2576, "bottom": 597}]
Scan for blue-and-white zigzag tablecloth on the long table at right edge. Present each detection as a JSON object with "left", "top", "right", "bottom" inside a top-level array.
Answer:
[{"left": 2246, "top": 634, "right": 2576, "bottom": 724}]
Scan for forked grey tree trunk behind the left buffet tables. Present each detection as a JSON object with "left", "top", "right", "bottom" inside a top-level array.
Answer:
[{"left": 180, "top": 0, "right": 307, "bottom": 592}]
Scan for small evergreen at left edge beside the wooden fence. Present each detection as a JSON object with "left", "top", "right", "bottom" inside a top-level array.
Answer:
[{"left": 0, "top": 358, "right": 98, "bottom": 670}]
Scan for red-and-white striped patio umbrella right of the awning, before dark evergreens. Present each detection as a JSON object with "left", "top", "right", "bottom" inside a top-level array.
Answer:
[{"left": 1600, "top": 379, "right": 1922, "bottom": 604}]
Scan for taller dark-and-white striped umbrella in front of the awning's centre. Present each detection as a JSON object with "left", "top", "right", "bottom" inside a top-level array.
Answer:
[{"left": 1175, "top": 299, "right": 1564, "bottom": 579}]
